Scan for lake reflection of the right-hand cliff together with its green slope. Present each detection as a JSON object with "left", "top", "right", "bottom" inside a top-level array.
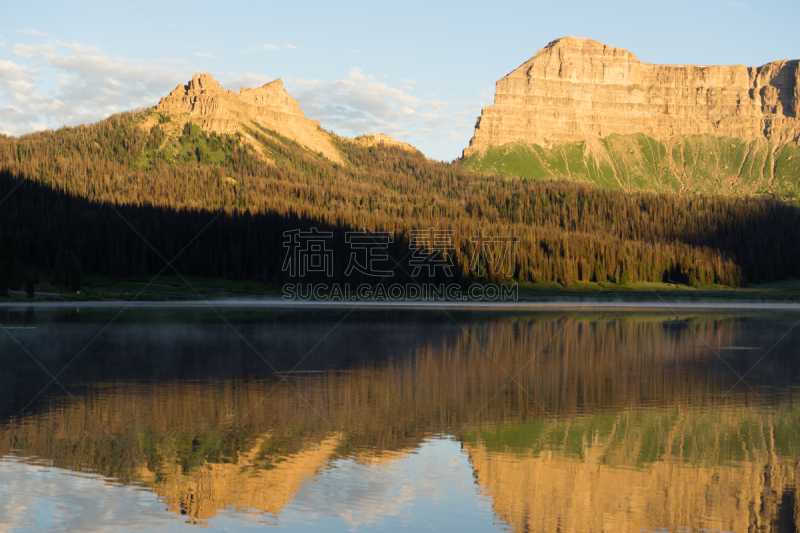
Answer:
[{"left": 464, "top": 410, "right": 800, "bottom": 533}]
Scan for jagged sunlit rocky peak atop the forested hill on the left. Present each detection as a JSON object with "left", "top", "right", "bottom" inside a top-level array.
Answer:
[{"left": 156, "top": 74, "right": 342, "bottom": 162}]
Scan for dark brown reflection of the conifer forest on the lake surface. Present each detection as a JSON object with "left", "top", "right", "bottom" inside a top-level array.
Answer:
[{"left": 6, "top": 311, "right": 800, "bottom": 479}]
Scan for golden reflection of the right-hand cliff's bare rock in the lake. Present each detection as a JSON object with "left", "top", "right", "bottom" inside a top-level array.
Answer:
[{"left": 465, "top": 445, "right": 800, "bottom": 533}]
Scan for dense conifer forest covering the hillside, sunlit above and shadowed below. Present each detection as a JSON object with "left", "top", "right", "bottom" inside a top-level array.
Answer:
[{"left": 0, "top": 110, "right": 800, "bottom": 287}]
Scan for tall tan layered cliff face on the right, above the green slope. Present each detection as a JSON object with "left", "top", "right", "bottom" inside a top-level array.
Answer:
[{"left": 464, "top": 37, "right": 800, "bottom": 157}]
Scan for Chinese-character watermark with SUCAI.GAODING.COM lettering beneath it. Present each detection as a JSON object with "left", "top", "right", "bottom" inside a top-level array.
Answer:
[{"left": 282, "top": 223, "right": 520, "bottom": 303}]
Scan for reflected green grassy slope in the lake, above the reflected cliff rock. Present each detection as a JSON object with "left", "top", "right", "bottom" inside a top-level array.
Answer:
[{"left": 461, "top": 403, "right": 800, "bottom": 468}]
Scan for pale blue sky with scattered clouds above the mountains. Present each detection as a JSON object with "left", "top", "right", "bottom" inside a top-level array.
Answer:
[{"left": 0, "top": 0, "right": 800, "bottom": 161}]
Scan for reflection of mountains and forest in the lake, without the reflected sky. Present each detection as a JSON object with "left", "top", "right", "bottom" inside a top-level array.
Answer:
[{"left": 0, "top": 314, "right": 800, "bottom": 532}]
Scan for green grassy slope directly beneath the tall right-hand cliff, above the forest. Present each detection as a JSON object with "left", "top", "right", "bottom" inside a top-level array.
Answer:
[{"left": 463, "top": 134, "right": 800, "bottom": 202}]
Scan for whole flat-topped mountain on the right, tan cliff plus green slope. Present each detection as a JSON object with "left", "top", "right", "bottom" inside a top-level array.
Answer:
[{"left": 464, "top": 37, "right": 800, "bottom": 200}]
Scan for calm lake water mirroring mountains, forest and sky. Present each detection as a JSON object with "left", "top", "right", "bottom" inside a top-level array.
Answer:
[{"left": 0, "top": 307, "right": 800, "bottom": 533}]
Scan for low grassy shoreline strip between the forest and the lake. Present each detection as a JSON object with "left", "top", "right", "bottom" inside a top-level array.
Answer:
[{"left": 0, "top": 275, "right": 800, "bottom": 311}]
